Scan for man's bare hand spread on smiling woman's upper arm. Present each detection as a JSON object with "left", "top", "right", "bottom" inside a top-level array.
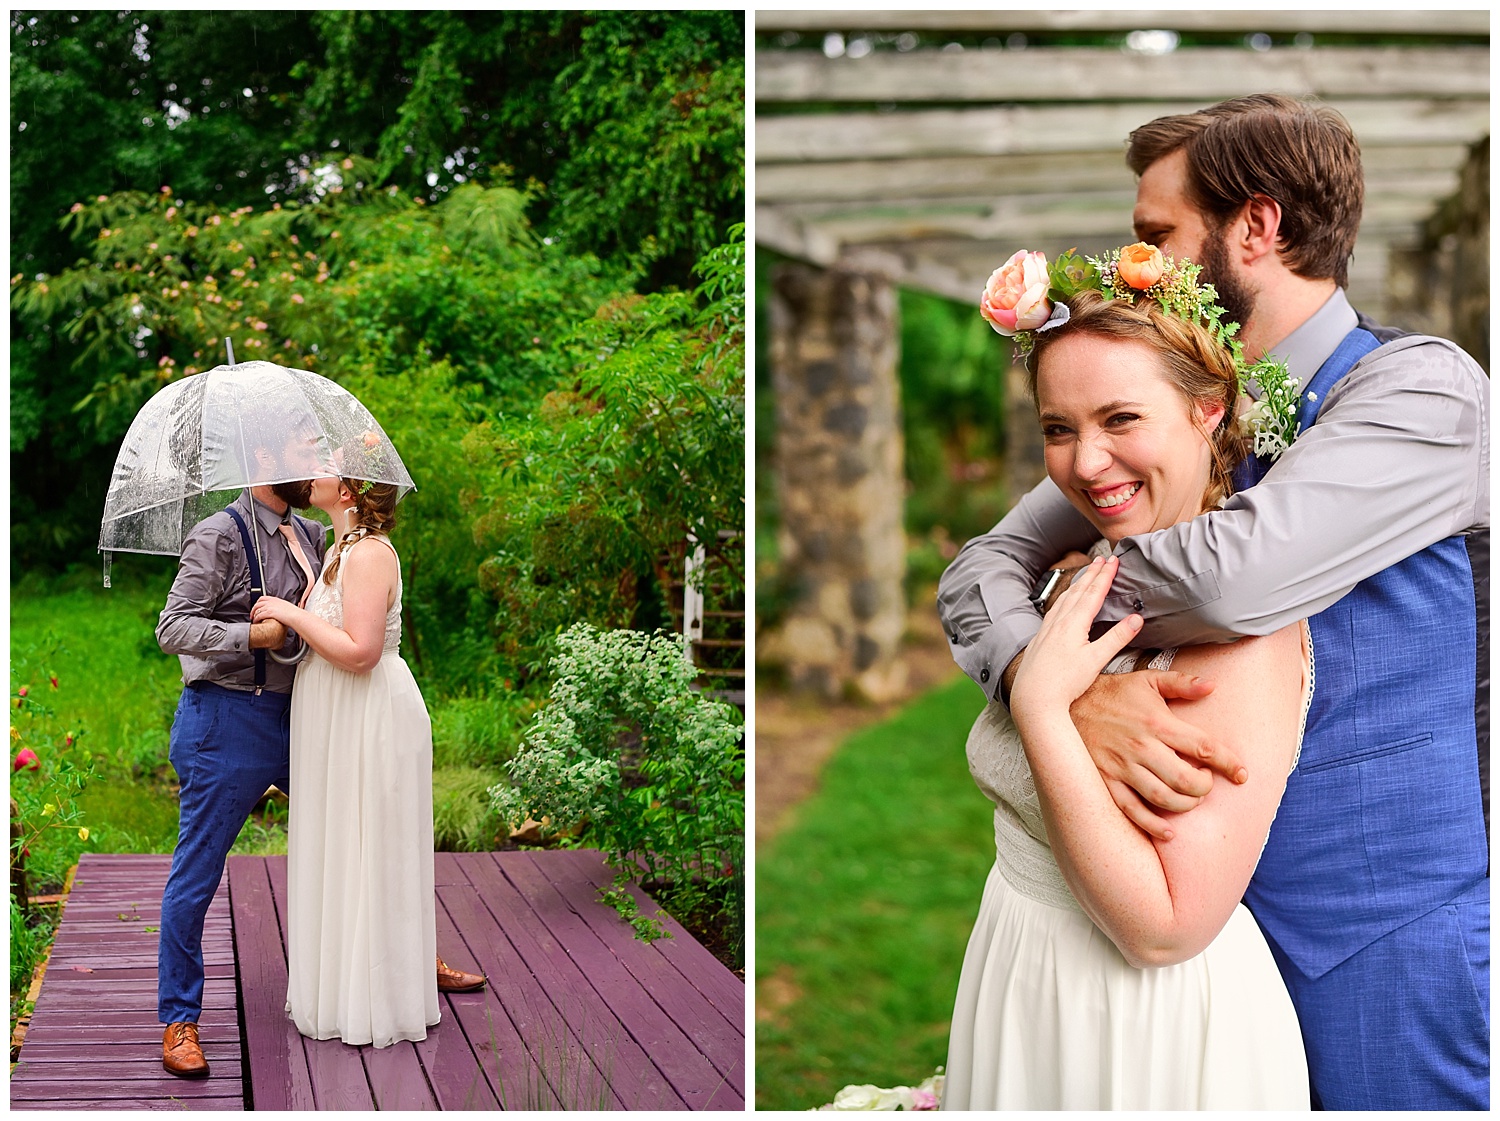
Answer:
[{"left": 1070, "top": 669, "right": 1250, "bottom": 840}]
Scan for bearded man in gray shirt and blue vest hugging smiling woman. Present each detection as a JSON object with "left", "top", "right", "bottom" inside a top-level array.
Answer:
[{"left": 938, "top": 95, "right": 1490, "bottom": 1109}]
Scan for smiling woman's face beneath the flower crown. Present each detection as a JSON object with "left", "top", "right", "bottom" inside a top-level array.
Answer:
[{"left": 1037, "top": 333, "right": 1224, "bottom": 543}]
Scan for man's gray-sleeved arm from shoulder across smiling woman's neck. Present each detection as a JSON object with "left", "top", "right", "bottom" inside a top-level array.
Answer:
[{"left": 1100, "top": 344, "right": 1488, "bottom": 647}]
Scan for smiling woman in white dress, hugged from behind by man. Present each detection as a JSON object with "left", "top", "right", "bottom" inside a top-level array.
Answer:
[{"left": 944, "top": 293, "right": 1313, "bottom": 1110}]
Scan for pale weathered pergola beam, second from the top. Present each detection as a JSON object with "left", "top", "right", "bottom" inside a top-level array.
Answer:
[{"left": 755, "top": 47, "right": 1490, "bottom": 105}]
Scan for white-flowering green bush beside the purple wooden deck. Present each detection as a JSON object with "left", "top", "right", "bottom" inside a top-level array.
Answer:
[{"left": 491, "top": 623, "right": 744, "bottom": 941}]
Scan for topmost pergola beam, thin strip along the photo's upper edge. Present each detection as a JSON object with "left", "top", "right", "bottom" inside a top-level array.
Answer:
[{"left": 755, "top": 8, "right": 1490, "bottom": 36}]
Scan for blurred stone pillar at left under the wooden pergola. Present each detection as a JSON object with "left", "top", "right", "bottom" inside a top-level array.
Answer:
[{"left": 771, "top": 264, "right": 906, "bottom": 699}]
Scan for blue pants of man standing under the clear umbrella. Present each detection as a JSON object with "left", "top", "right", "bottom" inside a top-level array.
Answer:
[{"left": 156, "top": 684, "right": 291, "bottom": 1023}]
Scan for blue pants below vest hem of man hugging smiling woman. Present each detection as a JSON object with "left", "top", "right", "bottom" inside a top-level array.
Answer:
[{"left": 1271, "top": 878, "right": 1490, "bottom": 1110}]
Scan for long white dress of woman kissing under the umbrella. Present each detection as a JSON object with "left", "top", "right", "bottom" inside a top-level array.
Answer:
[{"left": 287, "top": 534, "right": 440, "bottom": 1047}]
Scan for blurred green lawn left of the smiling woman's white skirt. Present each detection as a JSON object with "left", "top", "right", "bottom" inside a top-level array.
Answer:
[{"left": 755, "top": 678, "right": 995, "bottom": 1109}]
